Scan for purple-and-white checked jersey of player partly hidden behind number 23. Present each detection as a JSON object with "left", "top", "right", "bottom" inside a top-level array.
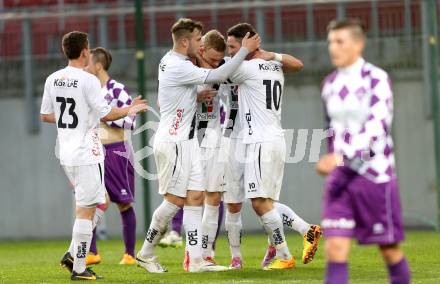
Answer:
[{"left": 102, "top": 79, "right": 136, "bottom": 130}]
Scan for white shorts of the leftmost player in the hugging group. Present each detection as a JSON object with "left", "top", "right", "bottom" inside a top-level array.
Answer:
[{"left": 153, "top": 139, "right": 205, "bottom": 198}]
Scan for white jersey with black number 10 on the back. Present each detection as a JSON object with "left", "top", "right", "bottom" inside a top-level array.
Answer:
[{"left": 230, "top": 59, "right": 284, "bottom": 144}]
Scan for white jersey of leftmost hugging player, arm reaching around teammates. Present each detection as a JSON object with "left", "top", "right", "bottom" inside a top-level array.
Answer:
[{"left": 155, "top": 50, "right": 209, "bottom": 142}]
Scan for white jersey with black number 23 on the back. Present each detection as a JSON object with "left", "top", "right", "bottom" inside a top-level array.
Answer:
[{"left": 40, "top": 66, "right": 111, "bottom": 166}]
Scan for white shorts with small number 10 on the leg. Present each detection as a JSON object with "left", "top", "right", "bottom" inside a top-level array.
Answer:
[{"left": 244, "top": 137, "right": 286, "bottom": 201}]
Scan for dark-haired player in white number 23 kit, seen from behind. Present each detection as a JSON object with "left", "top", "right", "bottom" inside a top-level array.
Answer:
[{"left": 40, "top": 31, "right": 147, "bottom": 280}]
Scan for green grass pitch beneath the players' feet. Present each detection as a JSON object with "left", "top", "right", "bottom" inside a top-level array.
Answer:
[{"left": 0, "top": 231, "right": 440, "bottom": 283}]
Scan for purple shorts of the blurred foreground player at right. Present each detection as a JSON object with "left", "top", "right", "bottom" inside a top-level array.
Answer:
[{"left": 322, "top": 168, "right": 404, "bottom": 245}]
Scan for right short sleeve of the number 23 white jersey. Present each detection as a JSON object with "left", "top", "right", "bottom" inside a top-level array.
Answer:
[{"left": 84, "top": 77, "right": 112, "bottom": 118}]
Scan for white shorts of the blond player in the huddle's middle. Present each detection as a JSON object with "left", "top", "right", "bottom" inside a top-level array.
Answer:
[{"left": 200, "top": 147, "right": 225, "bottom": 192}]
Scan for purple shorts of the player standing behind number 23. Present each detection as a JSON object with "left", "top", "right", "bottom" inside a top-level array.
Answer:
[{"left": 104, "top": 142, "right": 134, "bottom": 204}]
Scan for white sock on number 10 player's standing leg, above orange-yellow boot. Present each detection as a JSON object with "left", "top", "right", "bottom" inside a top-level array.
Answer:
[{"left": 260, "top": 209, "right": 292, "bottom": 259}]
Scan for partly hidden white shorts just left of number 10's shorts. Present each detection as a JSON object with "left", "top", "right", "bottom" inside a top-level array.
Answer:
[{"left": 222, "top": 138, "right": 246, "bottom": 203}]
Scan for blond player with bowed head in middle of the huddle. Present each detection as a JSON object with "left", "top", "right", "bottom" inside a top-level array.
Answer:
[{"left": 196, "top": 30, "right": 226, "bottom": 263}]
